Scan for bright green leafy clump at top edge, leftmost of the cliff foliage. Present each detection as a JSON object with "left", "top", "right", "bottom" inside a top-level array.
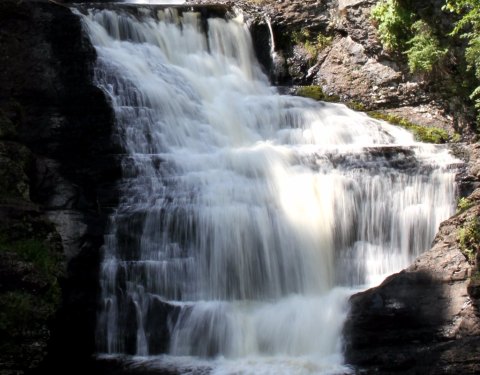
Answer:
[{"left": 371, "top": 0, "right": 413, "bottom": 51}]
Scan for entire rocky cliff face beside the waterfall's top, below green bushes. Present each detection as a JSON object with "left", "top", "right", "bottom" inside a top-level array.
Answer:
[{"left": 217, "top": 0, "right": 475, "bottom": 140}]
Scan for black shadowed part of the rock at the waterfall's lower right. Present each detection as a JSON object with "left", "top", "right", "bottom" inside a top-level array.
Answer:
[{"left": 344, "top": 271, "right": 480, "bottom": 374}]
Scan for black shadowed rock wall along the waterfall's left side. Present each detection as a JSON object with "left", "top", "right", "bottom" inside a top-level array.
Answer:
[{"left": 0, "top": 0, "right": 120, "bottom": 374}]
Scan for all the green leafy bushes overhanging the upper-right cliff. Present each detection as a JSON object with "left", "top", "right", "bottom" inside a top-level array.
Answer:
[{"left": 371, "top": 0, "right": 480, "bottom": 126}]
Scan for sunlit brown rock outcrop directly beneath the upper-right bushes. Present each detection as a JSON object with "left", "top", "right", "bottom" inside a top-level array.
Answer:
[{"left": 312, "top": 0, "right": 473, "bottom": 138}]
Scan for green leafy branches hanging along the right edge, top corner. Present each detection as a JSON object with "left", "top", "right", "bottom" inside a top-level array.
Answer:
[{"left": 443, "top": 0, "right": 480, "bottom": 124}]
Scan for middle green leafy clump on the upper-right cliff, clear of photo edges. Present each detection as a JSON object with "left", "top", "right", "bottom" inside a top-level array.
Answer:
[{"left": 405, "top": 20, "right": 448, "bottom": 73}]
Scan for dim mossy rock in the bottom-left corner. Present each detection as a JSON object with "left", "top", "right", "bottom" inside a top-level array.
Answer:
[{"left": 0, "top": 213, "right": 64, "bottom": 373}]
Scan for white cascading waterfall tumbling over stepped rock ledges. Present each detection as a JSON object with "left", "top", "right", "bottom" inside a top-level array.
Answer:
[{"left": 79, "top": 9, "right": 462, "bottom": 374}]
